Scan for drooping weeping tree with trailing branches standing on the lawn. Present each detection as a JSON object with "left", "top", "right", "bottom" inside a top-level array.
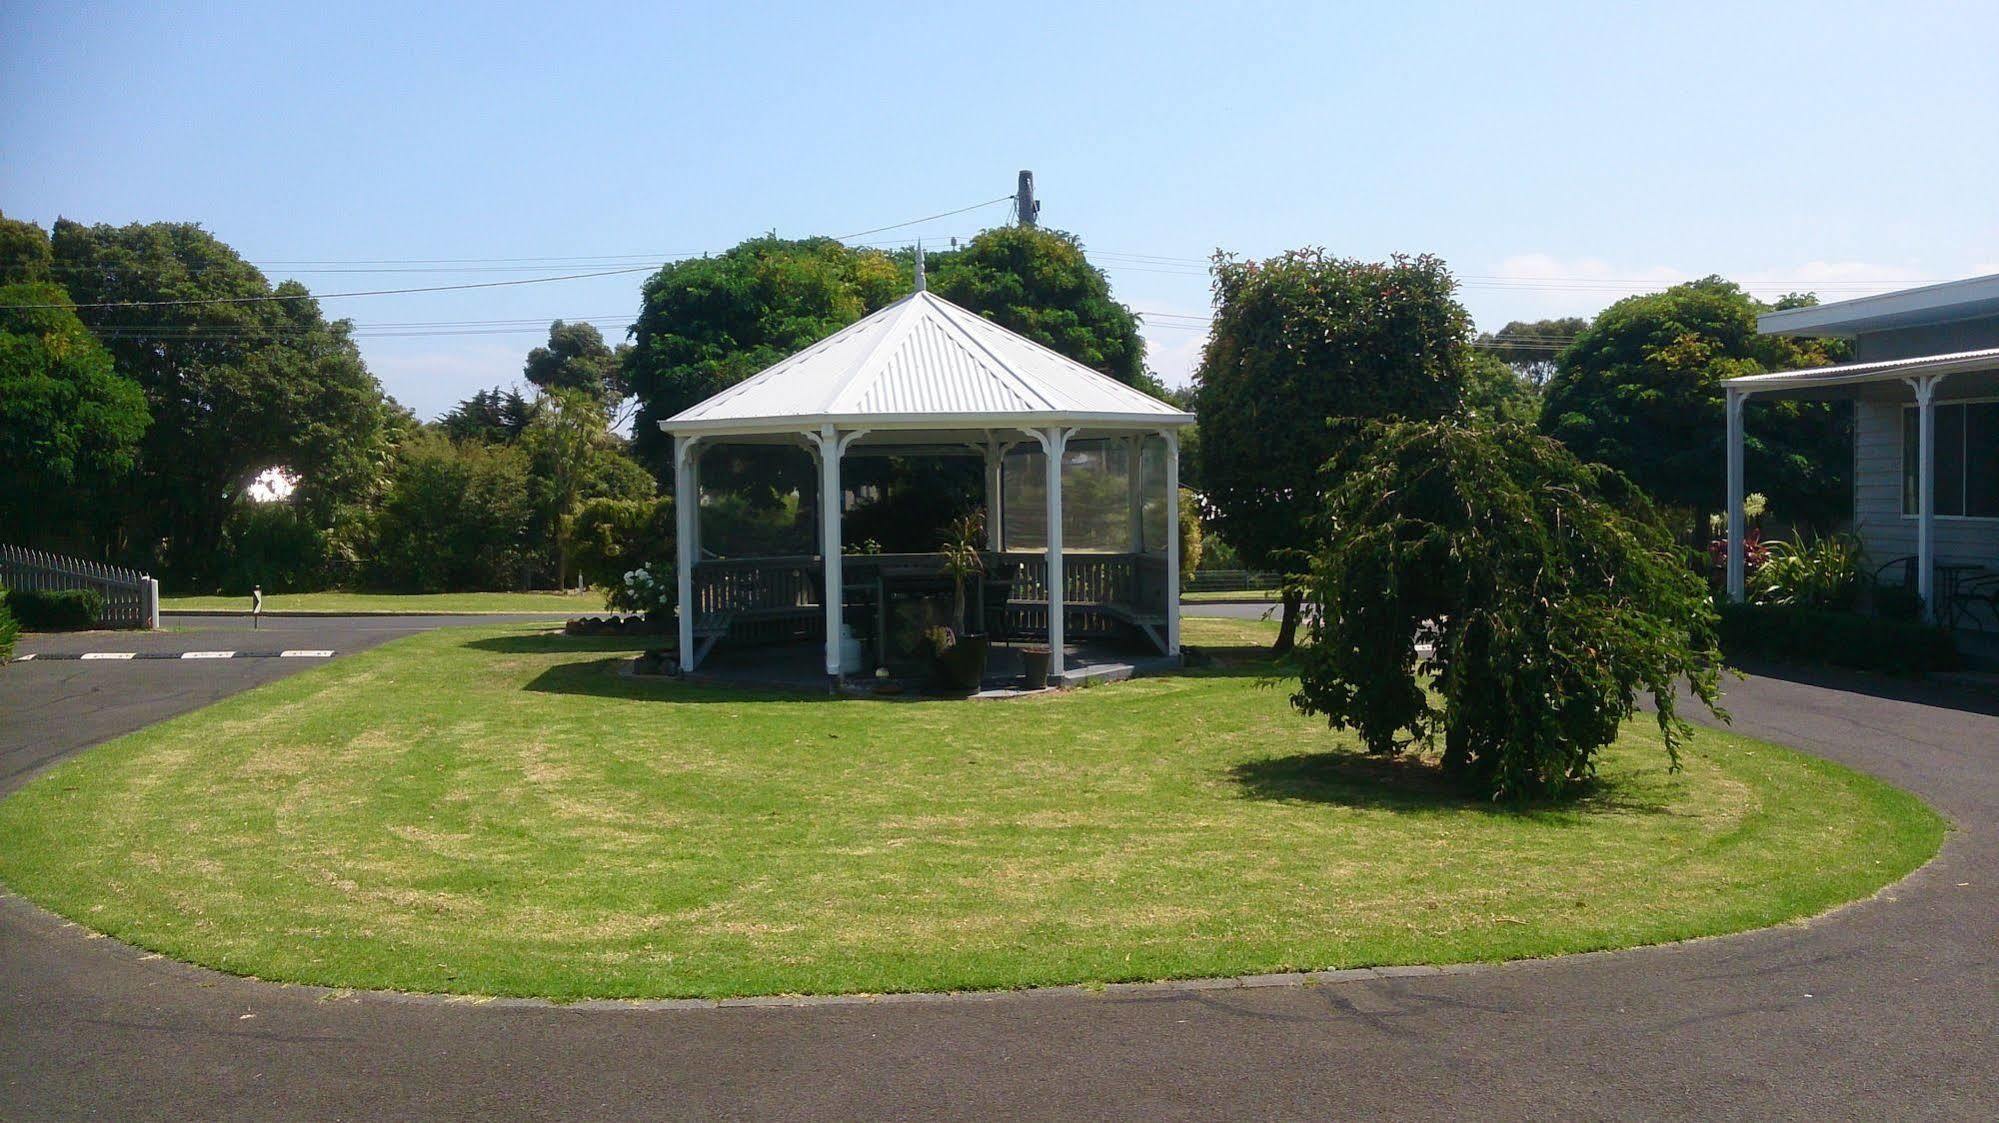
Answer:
[{"left": 1293, "top": 422, "right": 1721, "bottom": 799}]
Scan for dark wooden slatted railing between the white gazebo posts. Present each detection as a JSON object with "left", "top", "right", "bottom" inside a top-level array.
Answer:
[{"left": 692, "top": 550, "right": 1167, "bottom": 649}]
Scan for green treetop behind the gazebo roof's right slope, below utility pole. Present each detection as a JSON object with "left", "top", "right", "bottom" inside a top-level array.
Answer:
[{"left": 926, "top": 226, "right": 1167, "bottom": 398}]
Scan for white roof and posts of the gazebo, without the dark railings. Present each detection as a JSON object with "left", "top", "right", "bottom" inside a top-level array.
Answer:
[{"left": 660, "top": 256, "right": 1193, "bottom": 679}]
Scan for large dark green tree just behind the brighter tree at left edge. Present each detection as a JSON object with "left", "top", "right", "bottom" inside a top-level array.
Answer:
[{"left": 52, "top": 220, "right": 396, "bottom": 585}]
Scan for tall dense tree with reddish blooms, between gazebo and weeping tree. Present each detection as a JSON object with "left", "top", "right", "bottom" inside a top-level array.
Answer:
[{"left": 1195, "top": 248, "right": 1471, "bottom": 651}]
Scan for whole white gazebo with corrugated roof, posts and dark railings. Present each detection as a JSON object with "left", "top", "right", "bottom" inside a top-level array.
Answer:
[{"left": 660, "top": 258, "right": 1193, "bottom": 681}]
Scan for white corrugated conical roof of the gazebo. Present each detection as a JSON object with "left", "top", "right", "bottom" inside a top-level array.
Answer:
[{"left": 660, "top": 290, "right": 1193, "bottom": 440}]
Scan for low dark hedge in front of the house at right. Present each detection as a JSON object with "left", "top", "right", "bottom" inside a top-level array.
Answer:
[{"left": 1719, "top": 603, "right": 1957, "bottom": 673}]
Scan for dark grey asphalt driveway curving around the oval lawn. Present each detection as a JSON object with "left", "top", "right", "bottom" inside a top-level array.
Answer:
[{"left": 0, "top": 621, "right": 1999, "bottom": 1119}]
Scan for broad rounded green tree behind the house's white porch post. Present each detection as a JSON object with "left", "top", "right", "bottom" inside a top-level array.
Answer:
[{"left": 1541, "top": 276, "right": 1853, "bottom": 528}]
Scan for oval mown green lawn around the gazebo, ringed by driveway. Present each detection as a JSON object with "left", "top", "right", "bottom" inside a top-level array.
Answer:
[{"left": 0, "top": 619, "right": 1943, "bottom": 999}]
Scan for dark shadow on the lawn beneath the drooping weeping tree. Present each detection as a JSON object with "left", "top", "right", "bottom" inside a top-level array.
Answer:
[{"left": 1227, "top": 751, "right": 1675, "bottom": 821}]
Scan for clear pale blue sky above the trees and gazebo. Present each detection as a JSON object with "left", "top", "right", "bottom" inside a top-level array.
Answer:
[{"left": 0, "top": 4, "right": 1999, "bottom": 416}]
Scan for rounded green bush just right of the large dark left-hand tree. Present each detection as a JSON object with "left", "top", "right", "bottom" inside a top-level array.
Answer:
[{"left": 368, "top": 432, "right": 534, "bottom": 593}]
